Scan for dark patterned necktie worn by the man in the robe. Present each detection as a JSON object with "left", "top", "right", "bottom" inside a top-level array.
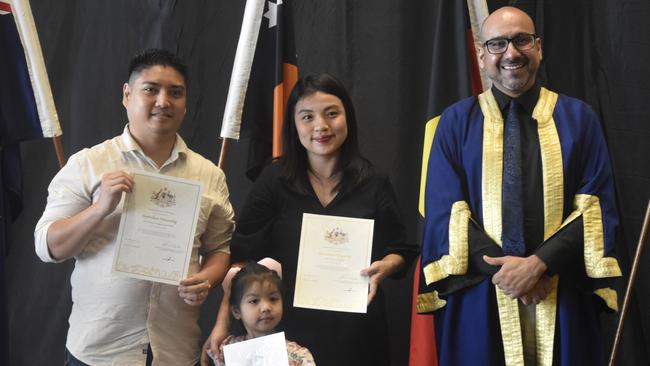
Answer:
[{"left": 501, "top": 100, "right": 526, "bottom": 257}]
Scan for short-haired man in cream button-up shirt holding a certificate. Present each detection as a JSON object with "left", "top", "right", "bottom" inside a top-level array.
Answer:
[{"left": 34, "top": 50, "right": 234, "bottom": 365}]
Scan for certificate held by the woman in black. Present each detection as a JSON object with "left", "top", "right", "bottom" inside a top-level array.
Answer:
[{"left": 293, "top": 214, "right": 374, "bottom": 313}]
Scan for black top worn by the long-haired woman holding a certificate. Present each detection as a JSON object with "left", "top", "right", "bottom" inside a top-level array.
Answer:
[{"left": 231, "top": 164, "right": 419, "bottom": 366}]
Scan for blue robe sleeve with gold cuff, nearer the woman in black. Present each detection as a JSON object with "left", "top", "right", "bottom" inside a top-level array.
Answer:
[{"left": 422, "top": 109, "right": 503, "bottom": 296}]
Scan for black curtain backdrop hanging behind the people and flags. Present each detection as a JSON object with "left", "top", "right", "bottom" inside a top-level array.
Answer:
[{"left": 2, "top": 0, "right": 650, "bottom": 366}]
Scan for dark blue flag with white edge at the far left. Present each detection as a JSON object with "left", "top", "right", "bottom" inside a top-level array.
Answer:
[{"left": 0, "top": 0, "right": 61, "bottom": 365}]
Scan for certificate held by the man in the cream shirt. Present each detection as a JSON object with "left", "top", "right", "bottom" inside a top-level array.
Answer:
[{"left": 113, "top": 171, "right": 203, "bottom": 285}]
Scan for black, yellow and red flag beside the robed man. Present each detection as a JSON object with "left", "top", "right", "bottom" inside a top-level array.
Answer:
[{"left": 409, "top": 0, "right": 487, "bottom": 366}]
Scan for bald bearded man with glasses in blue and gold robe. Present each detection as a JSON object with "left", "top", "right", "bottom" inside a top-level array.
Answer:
[{"left": 420, "top": 7, "right": 621, "bottom": 366}]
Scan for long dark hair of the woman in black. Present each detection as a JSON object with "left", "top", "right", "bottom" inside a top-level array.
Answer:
[{"left": 280, "top": 73, "right": 370, "bottom": 193}]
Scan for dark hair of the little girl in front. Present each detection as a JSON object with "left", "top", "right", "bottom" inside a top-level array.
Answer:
[{"left": 229, "top": 262, "right": 283, "bottom": 336}]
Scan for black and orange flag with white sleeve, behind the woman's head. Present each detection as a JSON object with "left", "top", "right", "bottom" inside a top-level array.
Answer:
[{"left": 221, "top": 0, "right": 298, "bottom": 180}]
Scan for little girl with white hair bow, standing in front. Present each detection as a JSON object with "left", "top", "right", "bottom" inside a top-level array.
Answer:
[{"left": 210, "top": 258, "right": 315, "bottom": 366}]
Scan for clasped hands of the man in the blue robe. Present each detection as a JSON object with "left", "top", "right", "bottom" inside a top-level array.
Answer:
[{"left": 483, "top": 255, "right": 546, "bottom": 299}]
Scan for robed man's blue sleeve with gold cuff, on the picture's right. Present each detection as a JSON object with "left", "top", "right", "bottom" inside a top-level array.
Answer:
[{"left": 535, "top": 101, "right": 621, "bottom": 310}]
